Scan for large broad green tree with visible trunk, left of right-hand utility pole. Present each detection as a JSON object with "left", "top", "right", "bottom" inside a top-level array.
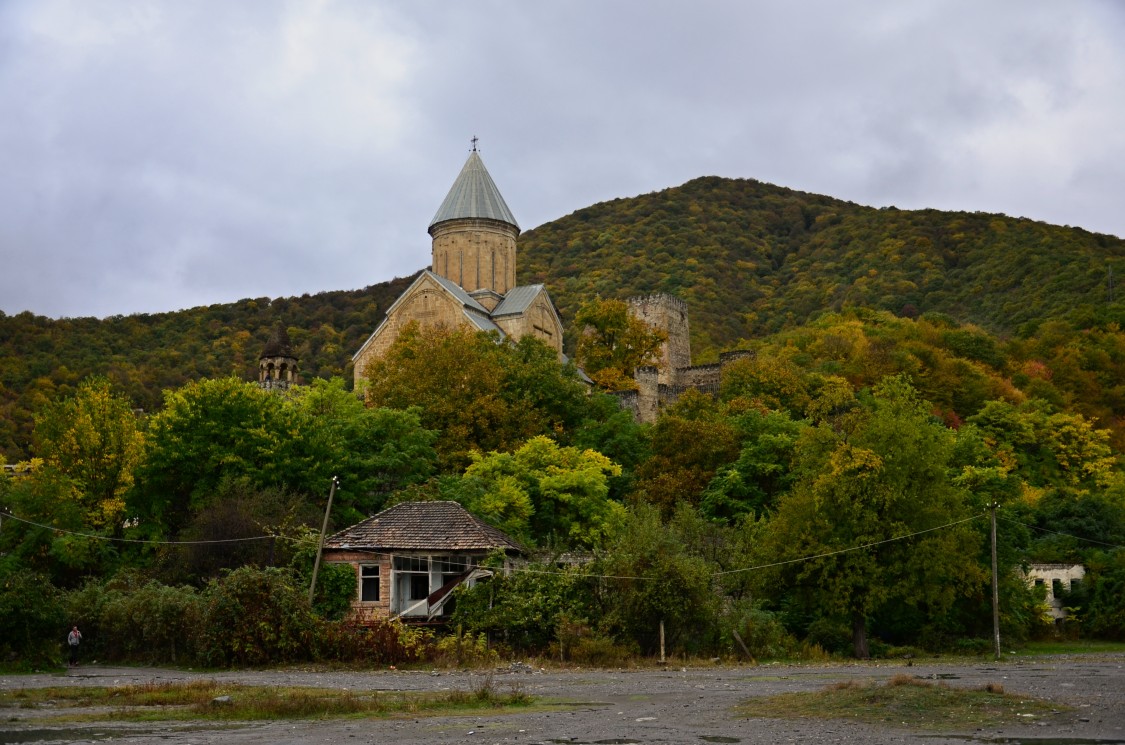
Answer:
[{"left": 759, "top": 377, "right": 982, "bottom": 657}]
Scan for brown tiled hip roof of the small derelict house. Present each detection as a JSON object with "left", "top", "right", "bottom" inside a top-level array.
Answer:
[{"left": 324, "top": 502, "right": 523, "bottom": 551}]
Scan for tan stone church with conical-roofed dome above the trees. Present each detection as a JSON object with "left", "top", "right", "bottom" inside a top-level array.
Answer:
[{"left": 352, "top": 147, "right": 563, "bottom": 391}]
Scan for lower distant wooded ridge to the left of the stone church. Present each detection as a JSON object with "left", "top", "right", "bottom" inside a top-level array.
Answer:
[{"left": 0, "top": 278, "right": 413, "bottom": 461}]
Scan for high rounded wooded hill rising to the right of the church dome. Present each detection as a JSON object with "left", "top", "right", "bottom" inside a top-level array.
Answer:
[{"left": 520, "top": 177, "right": 1125, "bottom": 357}]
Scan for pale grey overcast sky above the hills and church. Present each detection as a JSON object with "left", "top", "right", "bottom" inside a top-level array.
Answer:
[{"left": 0, "top": 0, "right": 1125, "bottom": 317}]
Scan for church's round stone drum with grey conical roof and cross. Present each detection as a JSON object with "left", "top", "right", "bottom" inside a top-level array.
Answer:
[{"left": 429, "top": 137, "right": 520, "bottom": 295}]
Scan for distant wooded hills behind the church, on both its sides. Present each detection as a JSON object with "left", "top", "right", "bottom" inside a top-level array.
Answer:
[{"left": 0, "top": 178, "right": 1125, "bottom": 460}]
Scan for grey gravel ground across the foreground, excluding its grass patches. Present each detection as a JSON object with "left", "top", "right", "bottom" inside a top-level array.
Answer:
[{"left": 0, "top": 655, "right": 1125, "bottom": 745}]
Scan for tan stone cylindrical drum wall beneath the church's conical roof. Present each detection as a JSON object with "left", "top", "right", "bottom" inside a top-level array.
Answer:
[{"left": 432, "top": 219, "right": 519, "bottom": 295}]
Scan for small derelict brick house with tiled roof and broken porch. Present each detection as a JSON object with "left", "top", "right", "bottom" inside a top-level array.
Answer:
[{"left": 324, "top": 502, "right": 524, "bottom": 623}]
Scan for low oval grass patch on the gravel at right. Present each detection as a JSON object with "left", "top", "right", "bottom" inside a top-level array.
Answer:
[{"left": 738, "top": 675, "right": 1064, "bottom": 730}]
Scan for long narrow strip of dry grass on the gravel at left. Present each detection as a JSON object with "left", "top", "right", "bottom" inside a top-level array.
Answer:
[{"left": 0, "top": 679, "right": 532, "bottom": 721}]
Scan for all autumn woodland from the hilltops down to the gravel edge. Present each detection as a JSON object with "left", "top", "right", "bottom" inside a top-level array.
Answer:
[{"left": 0, "top": 179, "right": 1125, "bottom": 666}]
